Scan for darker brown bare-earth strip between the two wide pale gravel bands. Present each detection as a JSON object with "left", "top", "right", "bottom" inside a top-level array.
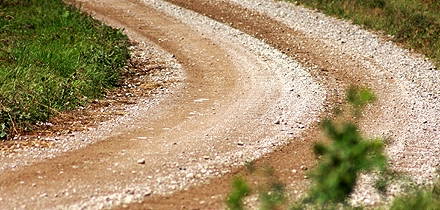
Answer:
[{"left": 118, "top": 0, "right": 386, "bottom": 209}]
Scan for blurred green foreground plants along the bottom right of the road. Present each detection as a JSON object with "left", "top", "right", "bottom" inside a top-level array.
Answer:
[{"left": 226, "top": 87, "right": 440, "bottom": 210}]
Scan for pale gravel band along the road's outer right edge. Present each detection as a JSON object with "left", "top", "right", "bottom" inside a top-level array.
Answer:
[{"left": 231, "top": 0, "right": 440, "bottom": 204}]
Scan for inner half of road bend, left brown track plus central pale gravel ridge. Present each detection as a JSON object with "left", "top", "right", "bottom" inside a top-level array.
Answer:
[{"left": 0, "top": 0, "right": 325, "bottom": 209}]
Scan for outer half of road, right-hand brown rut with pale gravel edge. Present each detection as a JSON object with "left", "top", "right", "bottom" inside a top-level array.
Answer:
[{"left": 124, "top": 0, "right": 440, "bottom": 208}]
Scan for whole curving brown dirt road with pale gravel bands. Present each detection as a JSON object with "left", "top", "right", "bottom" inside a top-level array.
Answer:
[{"left": 0, "top": 0, "right": 440, "bottom": 209}]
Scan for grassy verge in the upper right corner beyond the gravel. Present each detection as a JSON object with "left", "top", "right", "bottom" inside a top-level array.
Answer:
[{"left": 287, "top": 0, "right": 440, "bottom": 68}]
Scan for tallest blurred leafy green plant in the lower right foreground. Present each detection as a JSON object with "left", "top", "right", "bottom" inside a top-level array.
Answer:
[{"left": 305, "top": 87, "right": 386, "bottom": 206}]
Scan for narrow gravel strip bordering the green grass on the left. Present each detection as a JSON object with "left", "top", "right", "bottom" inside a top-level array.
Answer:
[{"left": 0, "top": 42, "right": 185, "bottom": 172}]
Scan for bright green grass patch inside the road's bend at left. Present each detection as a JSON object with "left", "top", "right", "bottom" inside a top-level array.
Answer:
[{"left": 0, "top": 0, "right": 129, "bottom": 138}]
